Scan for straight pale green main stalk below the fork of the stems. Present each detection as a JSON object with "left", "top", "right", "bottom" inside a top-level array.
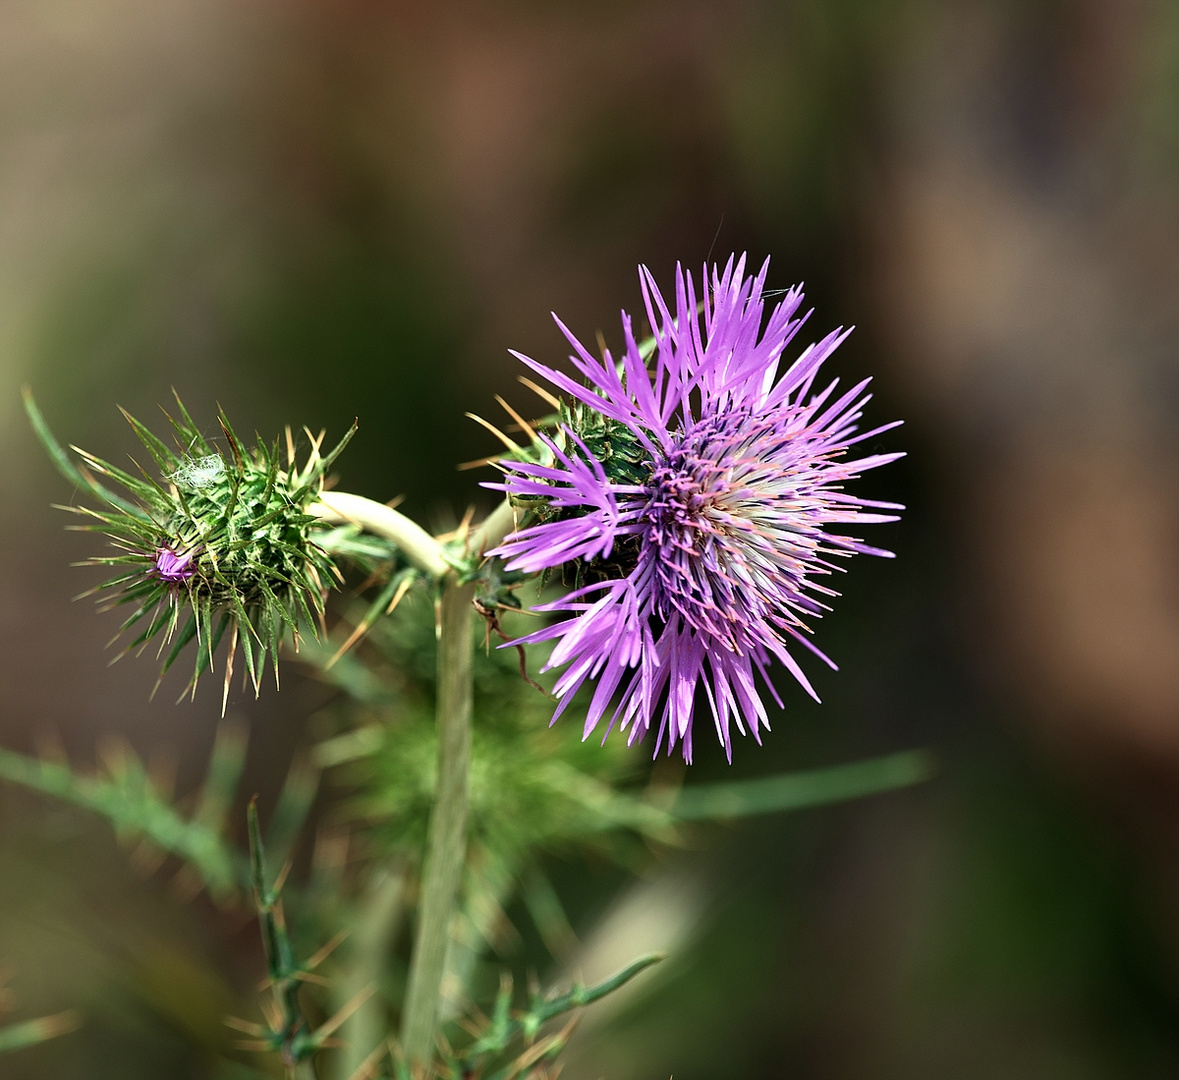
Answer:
[{"left": 401, "top": 578, "right": 475, "bottom": 1065}]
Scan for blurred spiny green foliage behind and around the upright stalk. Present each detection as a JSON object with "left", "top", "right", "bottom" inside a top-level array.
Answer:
[{"left": 0, "top": 570, "right": 929, "bottom": 1080}]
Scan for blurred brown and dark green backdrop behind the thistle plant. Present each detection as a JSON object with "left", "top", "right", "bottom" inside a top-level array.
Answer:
[{"left": 0, "top": 0, "right": 1179, "bottom": 1080}]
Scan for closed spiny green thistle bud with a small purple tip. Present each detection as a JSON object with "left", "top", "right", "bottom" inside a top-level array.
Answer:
[{"left": 25, "top": 393, "right": 356, "bottom": 712}]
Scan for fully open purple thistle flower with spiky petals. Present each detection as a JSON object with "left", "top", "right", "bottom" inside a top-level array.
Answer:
[{"left": 489, "top": 257, "right": 903, "bottom": 762}]
